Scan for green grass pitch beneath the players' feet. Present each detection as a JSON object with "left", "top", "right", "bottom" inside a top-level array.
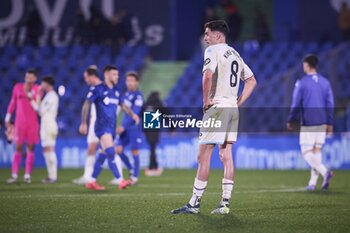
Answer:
[{"left": 0, "top": 170, "right": 350, "bottom": 233}]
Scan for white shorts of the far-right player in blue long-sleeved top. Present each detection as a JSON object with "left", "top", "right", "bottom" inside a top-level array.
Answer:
[{"left": 299, "top": 125, "right": 327, "bottom": 148}]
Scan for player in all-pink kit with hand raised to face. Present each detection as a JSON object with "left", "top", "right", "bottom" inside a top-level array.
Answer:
[{"left": 5, "top": 70, "right": 39, "bottom": 184}]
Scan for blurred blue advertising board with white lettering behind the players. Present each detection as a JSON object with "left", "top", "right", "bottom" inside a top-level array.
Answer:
[{"left": 0, "top": 134, "right": 350, "bottom": 170}]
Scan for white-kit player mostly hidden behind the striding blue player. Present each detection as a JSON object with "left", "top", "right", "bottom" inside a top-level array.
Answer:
[{"left": 73, "top": 65, "right": 102, "bottom": 185}]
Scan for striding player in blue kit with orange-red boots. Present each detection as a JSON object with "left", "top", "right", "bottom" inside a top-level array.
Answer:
[{"left": 79, "top": 65, "right": 139, "bottom": 190}]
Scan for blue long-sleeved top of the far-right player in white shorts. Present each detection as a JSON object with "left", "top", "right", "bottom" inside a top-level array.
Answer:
[{"left": 288, "top": 74, "right": 334, "bottom": 126}]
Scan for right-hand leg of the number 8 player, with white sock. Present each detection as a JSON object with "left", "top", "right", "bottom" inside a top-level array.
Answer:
[{"left": 211, "top": 142, "right": 234, "bottom": 214}]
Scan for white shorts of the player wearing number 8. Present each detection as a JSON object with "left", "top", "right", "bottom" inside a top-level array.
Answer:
[{"left": 199, "top": 105, "right": 239, "bottom": 144}]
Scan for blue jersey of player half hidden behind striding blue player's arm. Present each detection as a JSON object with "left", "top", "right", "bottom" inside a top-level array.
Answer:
[{"left": 122, "top": 90, "right": 143, "bottom": 128}]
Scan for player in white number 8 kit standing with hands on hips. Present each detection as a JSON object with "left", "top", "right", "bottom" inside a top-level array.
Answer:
[{"left": 171, "top": 20, "right": 256, "bottom": 214}]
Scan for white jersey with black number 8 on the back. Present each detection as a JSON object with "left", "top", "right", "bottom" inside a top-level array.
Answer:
[{"left": 203, "top": 44, "right": 254, "bottom": 107}]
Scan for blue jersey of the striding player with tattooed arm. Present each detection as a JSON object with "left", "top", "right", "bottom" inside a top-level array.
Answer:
[{"left": 86, "top": 83, "right": 120, "bottom": 137}]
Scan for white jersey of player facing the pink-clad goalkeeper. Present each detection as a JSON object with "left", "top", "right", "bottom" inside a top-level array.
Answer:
[{"left": 39, "top": 90, "right": 59, "bottom": 127}]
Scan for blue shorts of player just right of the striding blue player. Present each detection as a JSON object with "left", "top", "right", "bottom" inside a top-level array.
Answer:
[{"left": 118, "top": 126, "right": 143, "bottom": 150}]
